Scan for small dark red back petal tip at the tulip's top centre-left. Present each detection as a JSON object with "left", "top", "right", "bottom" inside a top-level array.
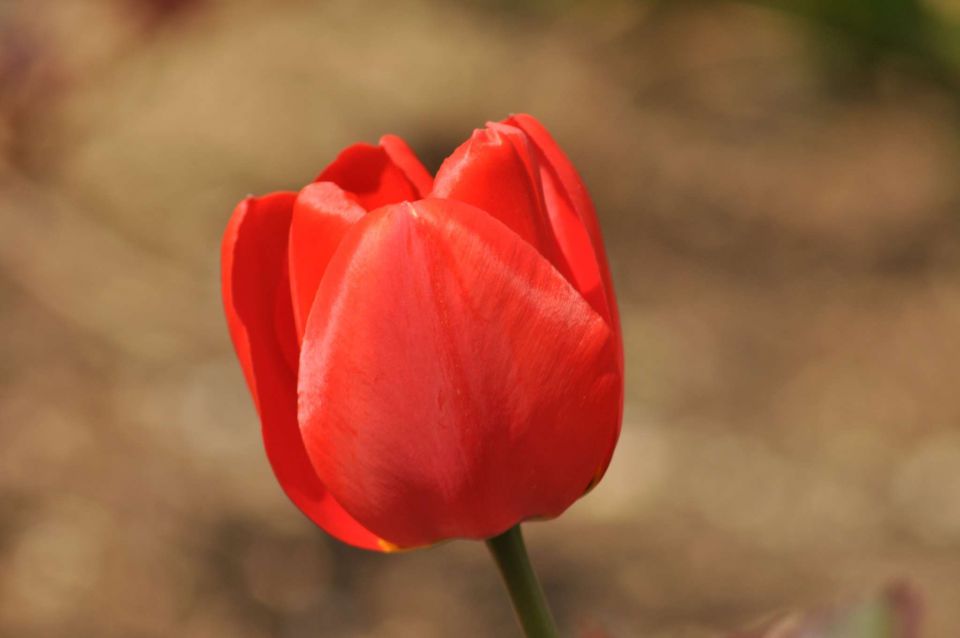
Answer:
[{"left": 315, "top": 136, "right": 429, "bottom": 210}]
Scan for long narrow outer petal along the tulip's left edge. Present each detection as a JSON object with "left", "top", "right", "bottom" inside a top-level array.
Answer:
[{"left": 221, "top": 193, "right": 380, "bottom": 549}]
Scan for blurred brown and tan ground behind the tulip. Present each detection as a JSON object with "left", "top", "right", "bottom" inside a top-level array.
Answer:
[{"left": 0, "top": 0, "right": 960, "bottom": 638}]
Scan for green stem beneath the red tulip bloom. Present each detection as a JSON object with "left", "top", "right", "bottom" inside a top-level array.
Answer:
[{"left": 487, "top": 525, "right": 559, "bottom": 638}]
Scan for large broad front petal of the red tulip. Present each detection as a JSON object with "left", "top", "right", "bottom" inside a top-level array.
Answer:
[{"left": 299, "top": 200, "right": 620, "bottom": 547}]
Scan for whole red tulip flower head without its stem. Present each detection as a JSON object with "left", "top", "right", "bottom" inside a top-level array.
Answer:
[{"left": 222, "top": 115, "right": 623, "bottom": 550}]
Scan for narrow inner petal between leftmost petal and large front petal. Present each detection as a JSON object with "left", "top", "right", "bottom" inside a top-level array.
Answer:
[{"left": 289, "top": 182, "right": 366, "bottom": 342}]
